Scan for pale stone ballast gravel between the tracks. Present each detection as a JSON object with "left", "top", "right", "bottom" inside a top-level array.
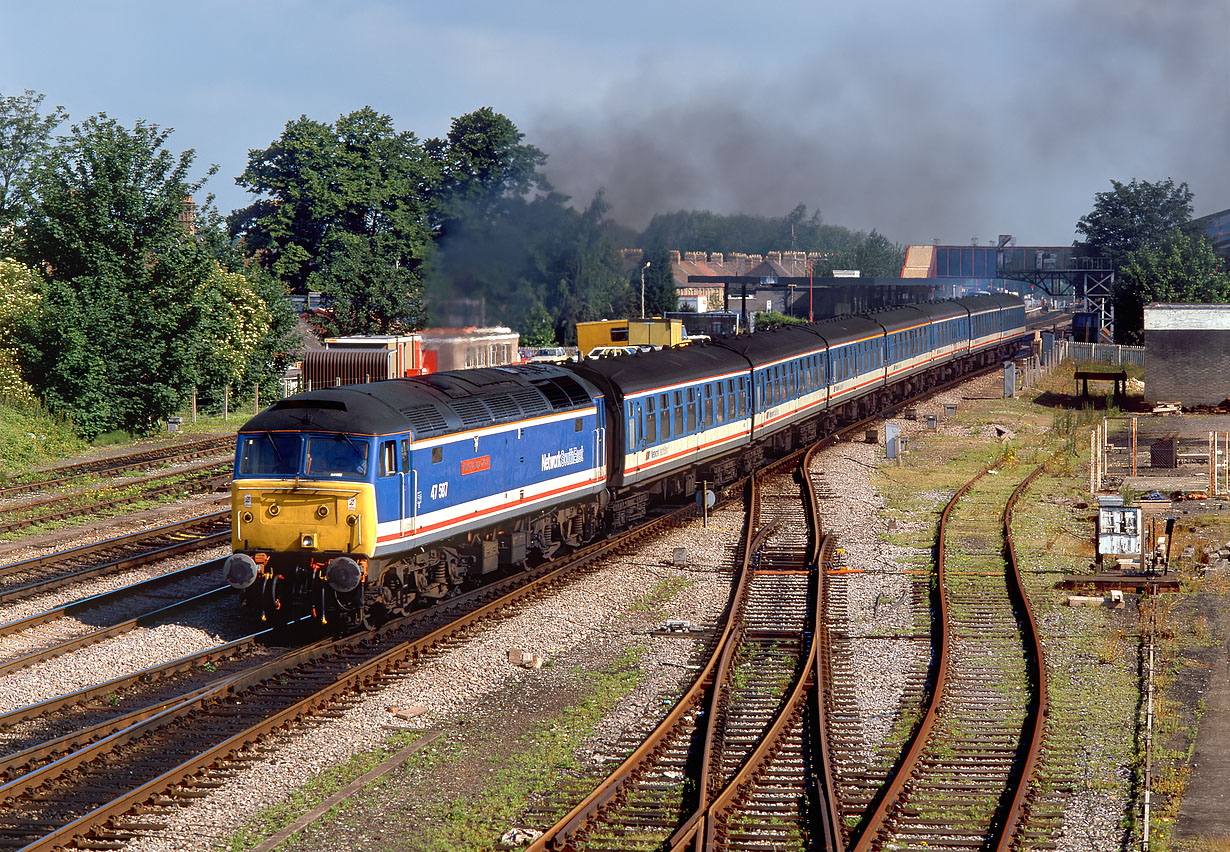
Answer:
[{"left": 0, "top": 386, "right": 1141, "bottom": 852}]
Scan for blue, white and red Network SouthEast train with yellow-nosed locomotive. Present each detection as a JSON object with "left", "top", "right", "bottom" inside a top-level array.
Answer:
[{"left": 225, "top": 295, "right": 1026, "bottom": 629}]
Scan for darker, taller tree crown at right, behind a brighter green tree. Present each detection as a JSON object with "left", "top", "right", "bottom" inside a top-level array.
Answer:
[{"left": 1076, "top": 177, "right": 1193, "bottom": 269}]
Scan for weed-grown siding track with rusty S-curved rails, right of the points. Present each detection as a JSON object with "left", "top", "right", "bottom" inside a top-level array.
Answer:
[{"left": 824, "top": 467, "right": 1047, "bottom": 852}]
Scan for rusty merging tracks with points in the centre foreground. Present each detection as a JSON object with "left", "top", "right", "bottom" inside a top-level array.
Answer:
[{"left": 529, "top": 442, "right": 822, "bottom": 852}]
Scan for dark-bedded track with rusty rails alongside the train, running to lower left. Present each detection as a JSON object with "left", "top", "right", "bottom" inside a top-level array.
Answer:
[{"left": 0, "top": 474, "right": 718, "bottom": 852}]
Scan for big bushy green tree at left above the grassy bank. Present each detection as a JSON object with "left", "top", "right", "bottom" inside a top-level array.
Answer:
[{"left": 18, "top": 113, "right": 216, "bottom": 438}]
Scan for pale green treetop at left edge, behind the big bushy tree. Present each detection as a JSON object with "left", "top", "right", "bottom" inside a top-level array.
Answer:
[{"left": 0, "top": 89, "right": 68, "bottom": 236}]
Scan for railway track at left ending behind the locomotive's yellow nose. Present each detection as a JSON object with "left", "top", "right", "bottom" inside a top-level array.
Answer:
[{"left": 0, "top": 511, "right": 230, "bottom": 604}]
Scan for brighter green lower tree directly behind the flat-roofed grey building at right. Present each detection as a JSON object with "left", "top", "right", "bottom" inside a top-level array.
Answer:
[{"left": 1114, "top": 229, "right": 1230, "bottom": 343}]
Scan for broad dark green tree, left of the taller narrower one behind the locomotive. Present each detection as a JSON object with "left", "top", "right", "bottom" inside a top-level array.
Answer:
[{"left": 230, "top": 107, "right": 438, "bottom": 333}]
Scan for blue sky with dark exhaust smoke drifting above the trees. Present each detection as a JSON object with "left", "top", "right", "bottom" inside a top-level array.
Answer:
[{"left": 0, "top": 0, "right": 1230, "bottom": 245}]
